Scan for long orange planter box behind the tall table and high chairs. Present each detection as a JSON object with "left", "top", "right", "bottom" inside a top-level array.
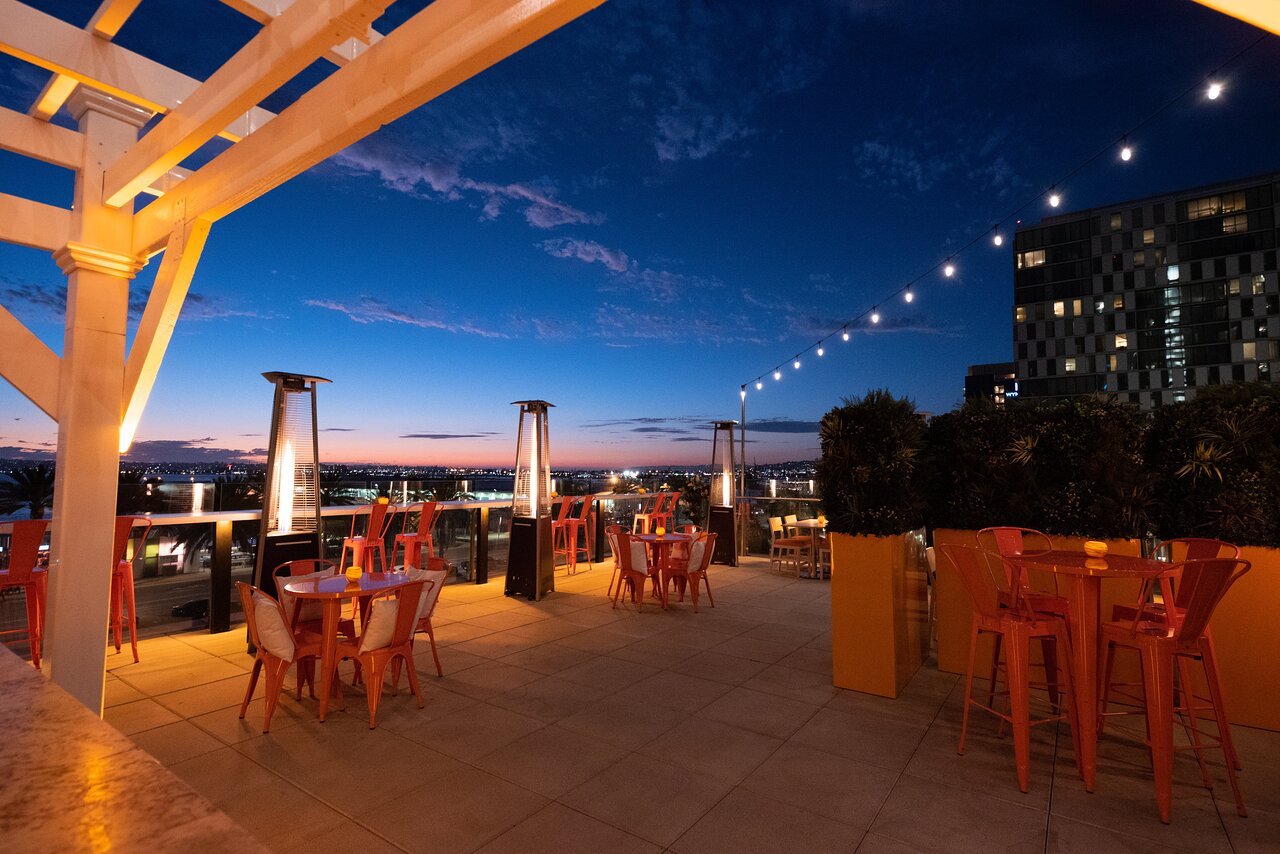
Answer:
[{"left": 931, "top": 529, "right": 1280, "bottom": 732}]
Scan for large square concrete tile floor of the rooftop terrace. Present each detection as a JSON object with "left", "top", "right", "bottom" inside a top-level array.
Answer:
[{"left": 106, "top": 560, "right": 1280, "bottom": 854}]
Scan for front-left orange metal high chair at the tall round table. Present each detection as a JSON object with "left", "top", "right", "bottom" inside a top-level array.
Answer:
[{"left": 940, "top": 545, "right": 1079, "bottom": 791}]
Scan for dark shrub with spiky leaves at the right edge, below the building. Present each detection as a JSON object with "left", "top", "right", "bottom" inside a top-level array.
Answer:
[{"left": 1146, "top": 384, "right": 1280, "bottom": 548}]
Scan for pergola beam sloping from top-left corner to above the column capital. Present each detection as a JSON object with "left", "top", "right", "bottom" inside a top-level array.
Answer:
[{"left": 0, "top": 0, "right": 273, "bottom": 141}]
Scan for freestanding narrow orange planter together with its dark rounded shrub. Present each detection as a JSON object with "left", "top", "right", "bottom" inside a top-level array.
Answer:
[{"left": 818, "top": 391, "right": 928, "bottom": 697}]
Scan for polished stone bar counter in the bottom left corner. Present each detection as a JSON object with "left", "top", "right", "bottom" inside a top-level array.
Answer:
[{"left": 0, "top": 647, "right": 266, "bottom": 854}]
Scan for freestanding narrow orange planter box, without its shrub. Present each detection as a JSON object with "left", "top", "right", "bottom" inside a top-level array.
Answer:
[{"left": 831, "top": 530, "right": 929, "bottom": 697}]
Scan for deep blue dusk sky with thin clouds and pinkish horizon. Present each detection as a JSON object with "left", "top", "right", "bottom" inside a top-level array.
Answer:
[{"left": 0, "top": 0, "right": 1280, "bottom": 469}]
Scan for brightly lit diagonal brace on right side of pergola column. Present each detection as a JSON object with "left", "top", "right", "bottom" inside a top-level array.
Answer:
[{"left": 120, "top": 222, "right": 210, "bottom": 453}]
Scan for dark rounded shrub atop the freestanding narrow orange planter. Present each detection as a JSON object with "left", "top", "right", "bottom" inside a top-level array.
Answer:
[{"left": 818, "top": 391, "right": 924, "bottom": 536}]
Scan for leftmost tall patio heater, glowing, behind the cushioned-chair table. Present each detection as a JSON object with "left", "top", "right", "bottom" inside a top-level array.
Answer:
[{"left": 253, "top": 371, "right": 329, "bottom": 595}]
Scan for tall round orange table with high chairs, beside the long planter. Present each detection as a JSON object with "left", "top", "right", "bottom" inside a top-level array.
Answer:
[{"left": 1005, "top": 549, "right": 1171, "bottom": 791}]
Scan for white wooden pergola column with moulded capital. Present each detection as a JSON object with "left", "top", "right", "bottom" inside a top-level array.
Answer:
[{"left": 45, "top": 86, "right": 150, "bottom": 714}]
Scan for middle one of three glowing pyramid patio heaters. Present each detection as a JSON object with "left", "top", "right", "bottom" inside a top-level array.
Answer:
[{"left": 503, "top": 401, "right": 556, "bottom": 599}]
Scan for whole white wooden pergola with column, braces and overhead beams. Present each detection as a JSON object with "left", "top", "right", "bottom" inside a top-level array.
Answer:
[{"left": 0, "top": 0, "right": 604, "bottom": 713}]
